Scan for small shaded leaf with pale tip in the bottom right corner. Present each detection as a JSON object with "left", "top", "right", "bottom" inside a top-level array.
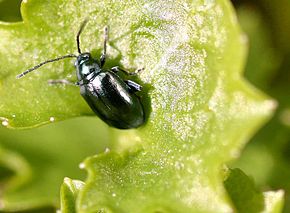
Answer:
[{"left": 225, "top": 169, "right": 284, "bottom": 213}]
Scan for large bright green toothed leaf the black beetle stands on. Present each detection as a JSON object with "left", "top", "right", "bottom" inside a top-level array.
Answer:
[{"left": 0, "top": 0, "right": 275, "bottom": 212}]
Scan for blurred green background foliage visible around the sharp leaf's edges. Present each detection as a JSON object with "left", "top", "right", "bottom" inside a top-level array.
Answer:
[{"left": 0, "top": 0, "right": 290, "bottom": 212}]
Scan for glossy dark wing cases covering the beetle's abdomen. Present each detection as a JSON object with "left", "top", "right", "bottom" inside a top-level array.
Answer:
[{"left": 81, "top": 71, "right": 144, "bottom": 129}]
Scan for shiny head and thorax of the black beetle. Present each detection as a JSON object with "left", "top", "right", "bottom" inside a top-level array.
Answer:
[{"left": 75, "top": 53, "right": 101, "bottom": 81}]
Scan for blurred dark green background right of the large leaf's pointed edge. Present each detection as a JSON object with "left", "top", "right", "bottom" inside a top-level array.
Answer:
[{"left": 231, "top": 0, "right": 290, "bottom": 212}]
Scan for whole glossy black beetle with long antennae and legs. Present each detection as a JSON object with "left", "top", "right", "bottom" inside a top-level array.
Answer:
[{"left": 16, "top": 19, "right": 145, "bottom": 129}]
